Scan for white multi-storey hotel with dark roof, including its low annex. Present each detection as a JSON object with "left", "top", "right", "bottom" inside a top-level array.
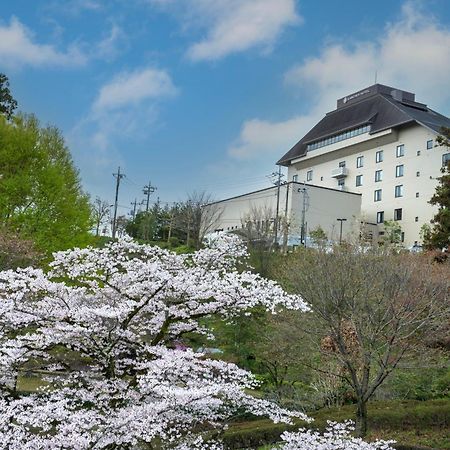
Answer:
[{"left": 210, "top": 84, "right": 450, "bottom": 247}]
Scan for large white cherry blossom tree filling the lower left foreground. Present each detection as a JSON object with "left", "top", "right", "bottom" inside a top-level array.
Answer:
[{"left": 0, "top": 236, "right": 310, "bottom": 450}]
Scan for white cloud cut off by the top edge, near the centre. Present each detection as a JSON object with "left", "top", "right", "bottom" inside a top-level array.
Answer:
[{"left": 150, "top": 0, "right": 301, "bottom": 61}]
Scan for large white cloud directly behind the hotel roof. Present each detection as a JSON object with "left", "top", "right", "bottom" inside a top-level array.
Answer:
[{"left": 228, "top": 1, "right": 450, "bottom": 162}]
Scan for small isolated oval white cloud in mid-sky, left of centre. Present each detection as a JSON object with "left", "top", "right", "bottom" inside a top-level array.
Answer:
[{"left": 93, "top": 68, "right": 176, "bottom": 111}]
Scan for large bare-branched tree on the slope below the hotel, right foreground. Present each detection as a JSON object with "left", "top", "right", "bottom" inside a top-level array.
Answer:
[{"left": 277, "top": 246, "right": 450, "bottom": 436}]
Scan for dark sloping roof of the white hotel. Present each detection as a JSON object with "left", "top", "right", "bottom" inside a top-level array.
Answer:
[{"left": 277, "top": 84, "right": 450, "bottom": 165}]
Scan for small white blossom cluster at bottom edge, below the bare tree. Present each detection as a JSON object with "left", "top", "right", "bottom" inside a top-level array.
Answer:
[{"left": 273, "top": 420, "right": 395, "bottom": 450}]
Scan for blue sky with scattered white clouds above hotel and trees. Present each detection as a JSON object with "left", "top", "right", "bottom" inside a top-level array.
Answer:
[{"left": 0, "top": 0, "right": 450, "bottom": 214}]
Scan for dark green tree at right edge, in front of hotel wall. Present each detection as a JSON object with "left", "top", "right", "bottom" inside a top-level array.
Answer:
[{"left": 425, "top": 127, "right": 450, "bottom": 248}]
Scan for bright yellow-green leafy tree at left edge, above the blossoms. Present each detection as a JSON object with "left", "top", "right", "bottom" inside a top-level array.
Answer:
[{"left": 0, "top": 115, "right": 92, "bottom": 253}]
